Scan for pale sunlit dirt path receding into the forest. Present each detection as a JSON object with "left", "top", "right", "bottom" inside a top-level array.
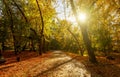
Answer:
[{"left": 31, "top": 51, "right": 91, "bottom": 77}]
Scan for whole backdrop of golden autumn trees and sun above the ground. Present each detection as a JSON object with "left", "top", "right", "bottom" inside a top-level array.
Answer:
[{"left": 0, "top": 0, "right": 120, "bottom": 62}]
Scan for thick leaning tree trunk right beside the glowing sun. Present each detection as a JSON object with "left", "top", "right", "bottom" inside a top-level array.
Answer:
[{"left": 70, "top": 0, "right": 97, "bottom": 63}]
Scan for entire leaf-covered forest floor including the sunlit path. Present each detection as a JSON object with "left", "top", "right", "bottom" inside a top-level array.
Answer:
[{"left": 0, "top": 51, "right": 120, "bottom": 77}]
